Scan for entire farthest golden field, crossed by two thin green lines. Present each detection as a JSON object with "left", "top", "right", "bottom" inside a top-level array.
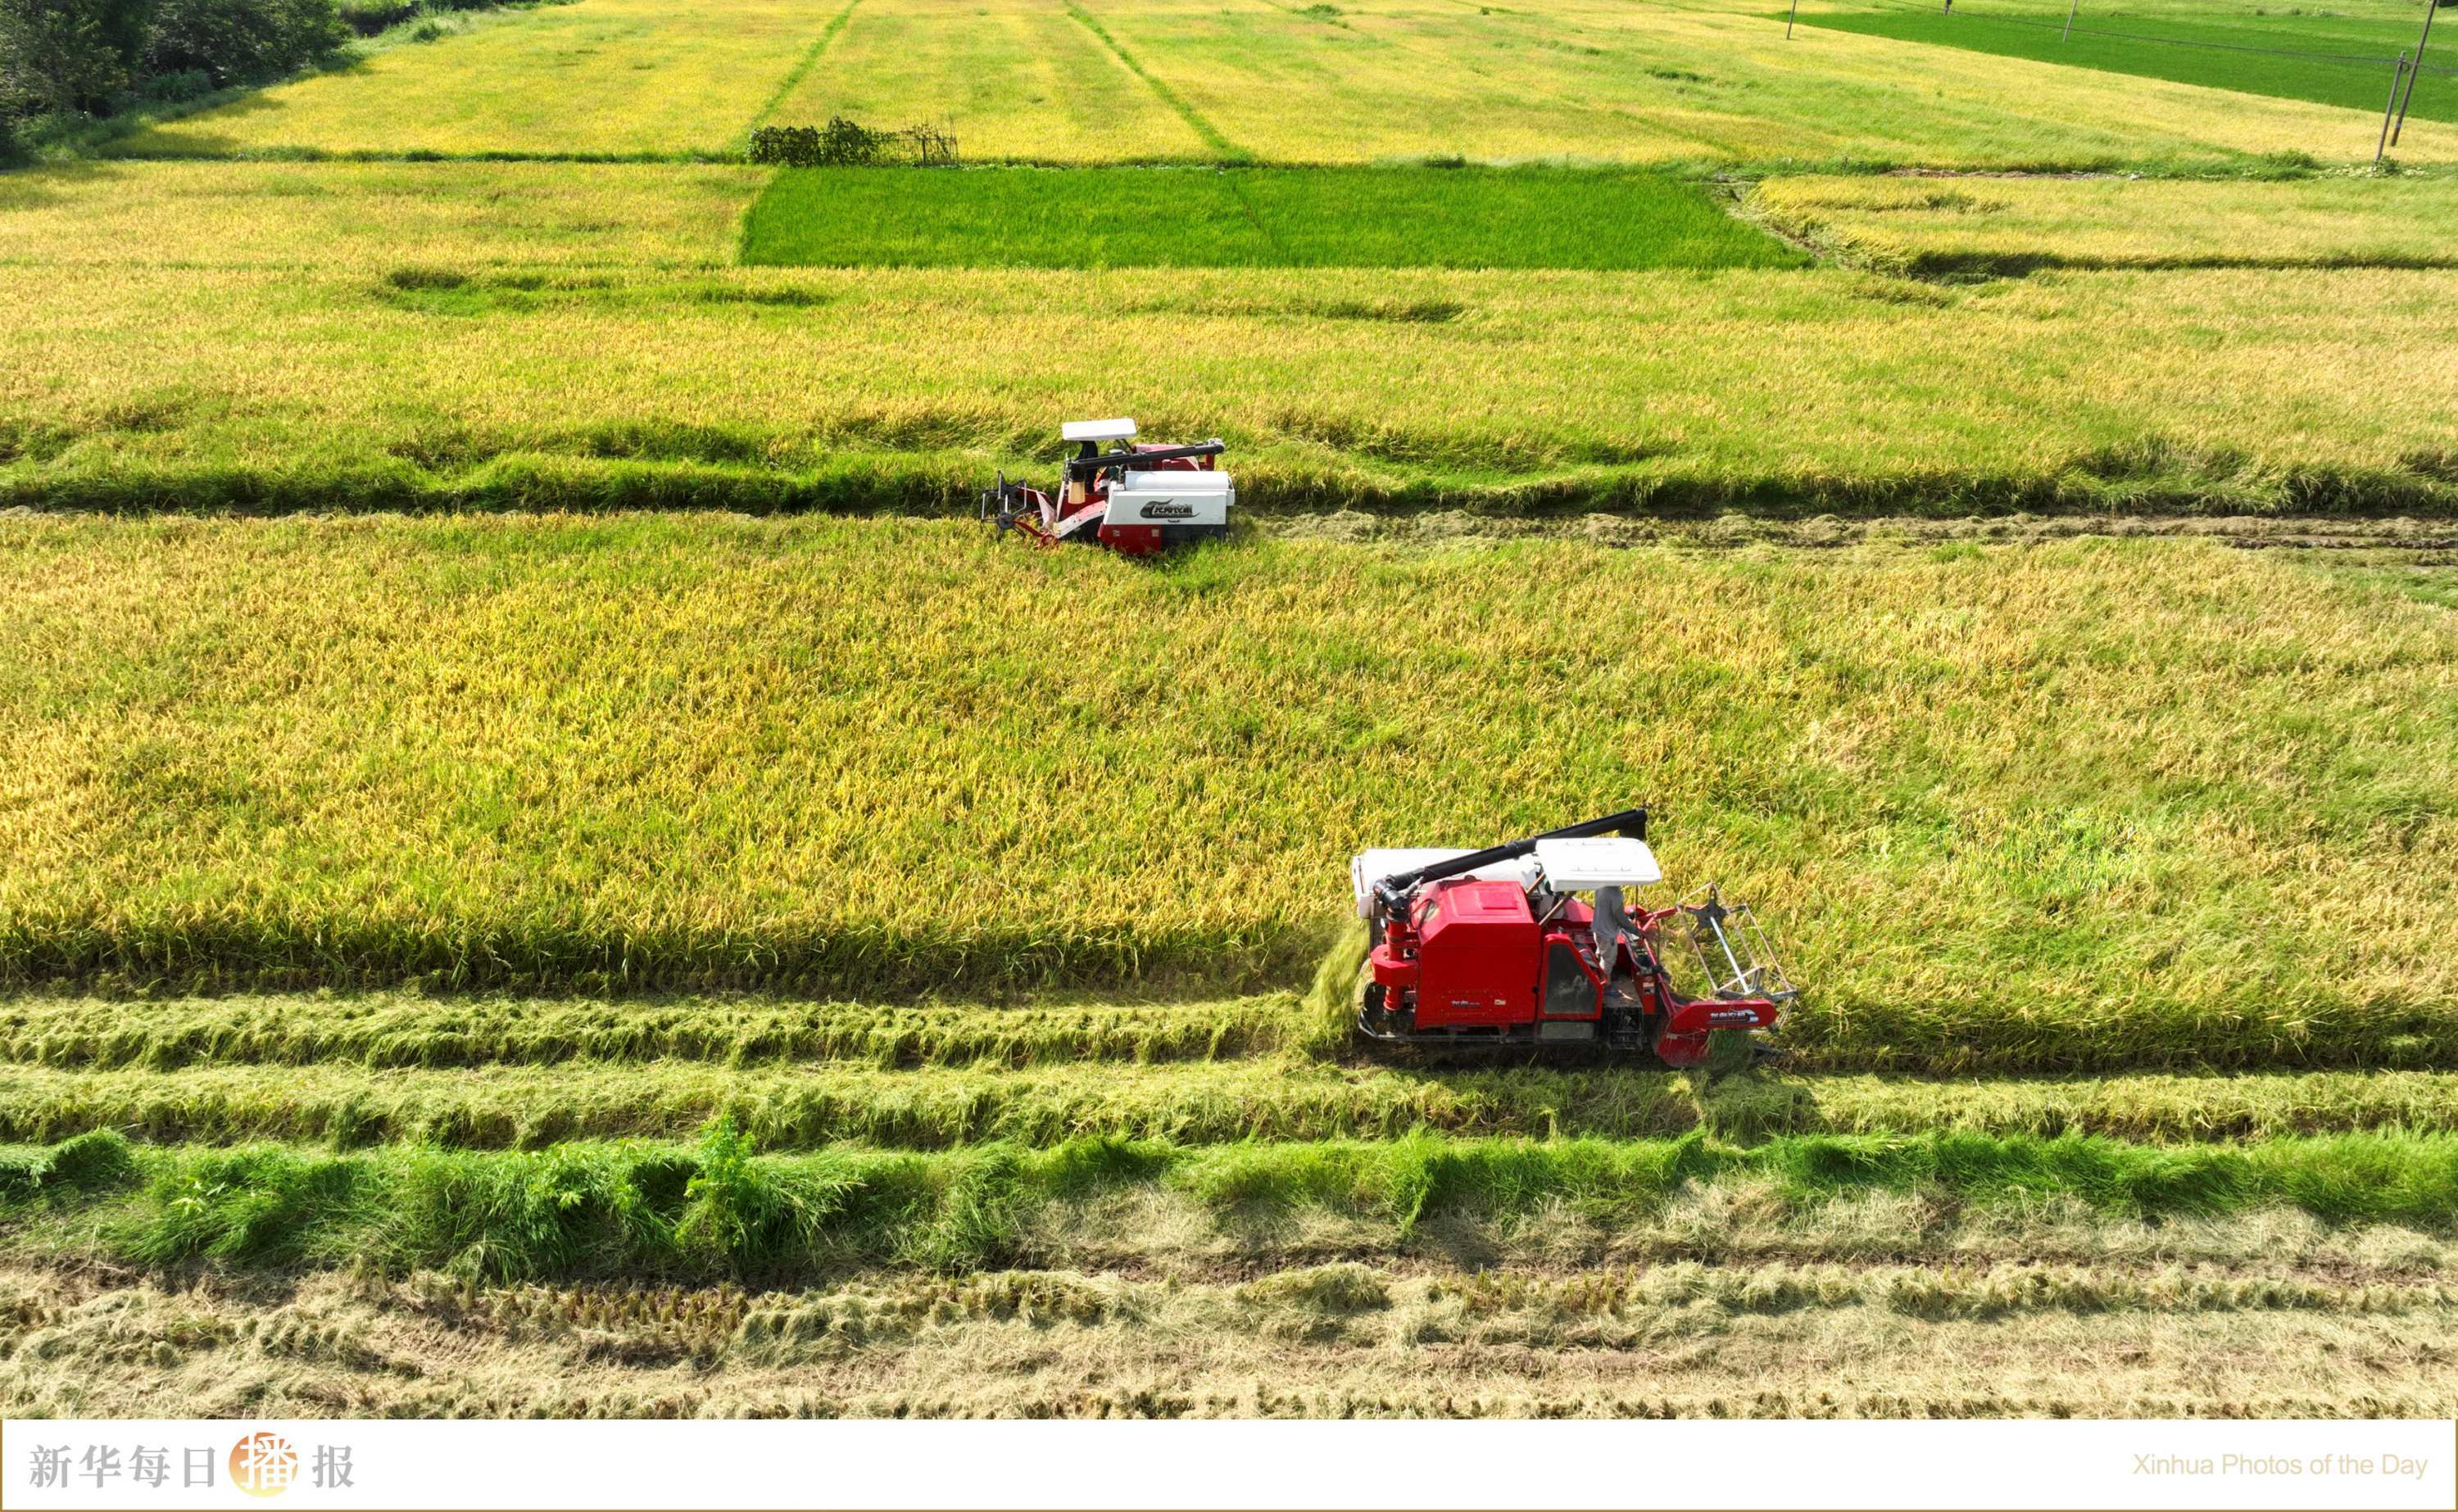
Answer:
[{"left": 123, "top": 0, "right": 2458, "bottom": 167}]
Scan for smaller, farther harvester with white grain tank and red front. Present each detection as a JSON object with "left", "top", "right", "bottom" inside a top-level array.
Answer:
[{"left": 981, "top": 420, "right": 1236, "bottom": 555}]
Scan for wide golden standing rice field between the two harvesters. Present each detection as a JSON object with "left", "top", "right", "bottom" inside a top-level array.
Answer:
[{"left": 0, "top": 516, "right": 2458, "bottom": 1072}]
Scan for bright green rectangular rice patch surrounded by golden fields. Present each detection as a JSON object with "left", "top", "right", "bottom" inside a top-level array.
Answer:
[{"left": 742, "top": 167, "right": 1807, "bottom": 270}]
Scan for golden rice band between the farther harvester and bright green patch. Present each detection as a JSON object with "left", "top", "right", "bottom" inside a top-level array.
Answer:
[{"left": 0, "top": 160, "right": 2458, "bottom": 514}]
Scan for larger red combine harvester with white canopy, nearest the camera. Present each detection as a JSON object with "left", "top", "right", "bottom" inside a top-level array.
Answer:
[{"left": 1349, "top": 809, "right": 1797, "bottom": 1067}]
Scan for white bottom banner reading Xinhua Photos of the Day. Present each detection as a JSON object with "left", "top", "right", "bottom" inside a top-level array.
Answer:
[{"left": 0, "top": 1419, "right": 2458, "bottom": 1510}]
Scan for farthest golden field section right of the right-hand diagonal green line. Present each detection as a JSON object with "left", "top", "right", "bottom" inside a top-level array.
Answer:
[{"left": 1057, "top": 0, "right": 2458, "bottom": 167}]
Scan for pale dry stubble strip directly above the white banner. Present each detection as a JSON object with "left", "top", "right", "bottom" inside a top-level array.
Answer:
[{"left": 0, "top": 1264, "right": 2458, "bottom": 1416}]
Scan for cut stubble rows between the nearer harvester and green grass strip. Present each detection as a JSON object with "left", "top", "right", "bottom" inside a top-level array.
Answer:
[{"left": 0, "top": 1037, "right": 2458, "bottom": 1151}]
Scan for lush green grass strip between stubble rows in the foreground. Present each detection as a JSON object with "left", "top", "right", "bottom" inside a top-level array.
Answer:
[{"left": 0, "top": 1124, "right": 2458, "bottom": 1281}]
